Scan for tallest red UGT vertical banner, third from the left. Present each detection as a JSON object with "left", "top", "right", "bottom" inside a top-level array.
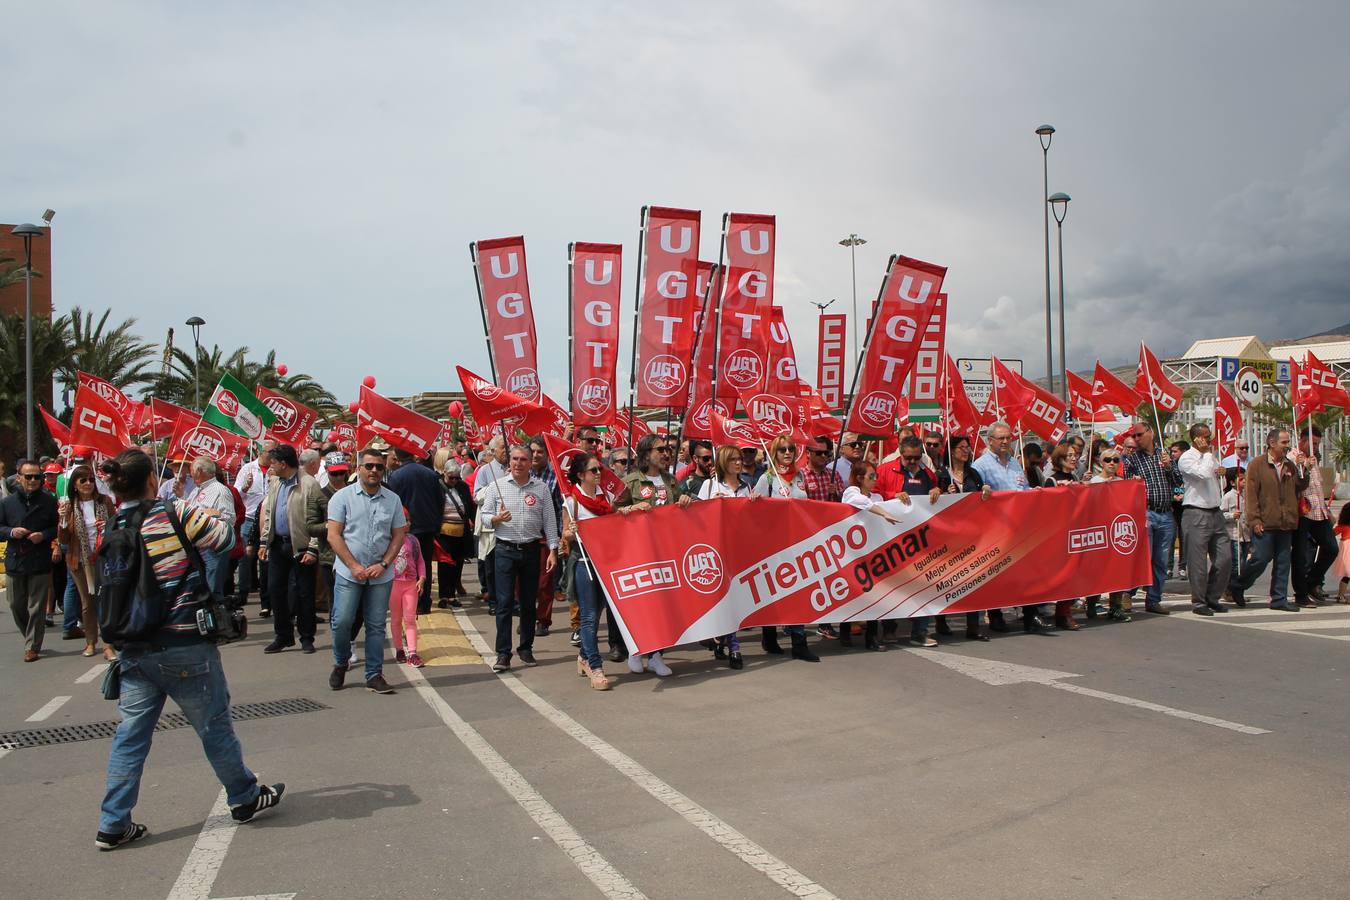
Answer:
[{"left": 636, "top": 206, "right": 701, "bottom": 409}]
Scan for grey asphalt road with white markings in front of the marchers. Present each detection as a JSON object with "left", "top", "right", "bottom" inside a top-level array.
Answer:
[{"left": 0, "top": 564, "right": 1350, "bottom": 900}]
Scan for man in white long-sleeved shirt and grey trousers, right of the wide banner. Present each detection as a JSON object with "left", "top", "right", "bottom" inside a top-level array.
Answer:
[{"left": 1177, "top": 422, "right": 1233, "bottom": 615}]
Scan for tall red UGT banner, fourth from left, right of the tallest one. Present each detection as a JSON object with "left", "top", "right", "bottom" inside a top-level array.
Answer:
[{"left": 717, "top": 212, "right": 776, "bottom": 399}]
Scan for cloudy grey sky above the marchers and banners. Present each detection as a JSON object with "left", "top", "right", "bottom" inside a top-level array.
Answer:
[{"left": 0, "top": 0, "right": 1350, "bottom": 399}]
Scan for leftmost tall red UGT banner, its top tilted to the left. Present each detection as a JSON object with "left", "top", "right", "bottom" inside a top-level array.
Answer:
[{"left": 473, "top": 237, "right": 541, "bottom": 399}]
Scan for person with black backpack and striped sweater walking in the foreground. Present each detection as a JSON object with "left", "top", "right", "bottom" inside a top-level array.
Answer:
[{"left": 95, "top": 449, "right": 286, "bottom": 850}]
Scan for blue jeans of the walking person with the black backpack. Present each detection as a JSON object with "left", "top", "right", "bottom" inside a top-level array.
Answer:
[{"left": 99, "top": 641, "right": 258, "bottom": 834}]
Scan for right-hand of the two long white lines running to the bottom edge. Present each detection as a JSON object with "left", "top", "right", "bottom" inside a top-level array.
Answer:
[{"left": 455, "top": 610, "right": 834, "bottom": 900}]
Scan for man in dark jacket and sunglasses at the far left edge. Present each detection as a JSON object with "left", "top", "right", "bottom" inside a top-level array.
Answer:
[{"left": 0, "top": 460, "right": 57, "bottom": 663}]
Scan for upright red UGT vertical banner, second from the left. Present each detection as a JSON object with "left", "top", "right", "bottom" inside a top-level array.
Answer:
[{"left": 568, "top": 242, "right": 624, "bottom": 425}]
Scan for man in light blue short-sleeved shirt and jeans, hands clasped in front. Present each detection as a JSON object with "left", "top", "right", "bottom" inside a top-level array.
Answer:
[{"left": 328, "top": 448, "right": 408, "bottom": 694}]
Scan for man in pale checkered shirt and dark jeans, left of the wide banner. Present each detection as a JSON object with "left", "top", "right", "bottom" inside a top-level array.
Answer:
[{"left": 478, "top": 447, "right": 558, "bottom": 672}]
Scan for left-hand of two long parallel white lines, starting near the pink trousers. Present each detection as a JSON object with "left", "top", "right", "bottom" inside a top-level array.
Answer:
[{"left": 404, "top": 668, "right": 645, "bottom": 900}]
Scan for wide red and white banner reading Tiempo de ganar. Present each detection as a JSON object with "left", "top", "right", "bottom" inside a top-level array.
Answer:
[{"left": 579, "top": 480, "right": 1150, "bottom": 653}]
